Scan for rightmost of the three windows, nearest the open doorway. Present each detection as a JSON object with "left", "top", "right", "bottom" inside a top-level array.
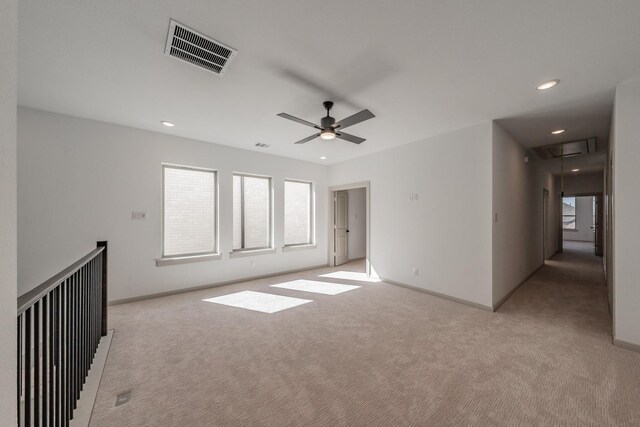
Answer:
[{"left": 284, "top": 180, "right": 313, "bottom": 246}]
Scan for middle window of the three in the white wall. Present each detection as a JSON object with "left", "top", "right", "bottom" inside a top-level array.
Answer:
[{"left": 233, "top": 174, "right": 271, "bottom": 251}]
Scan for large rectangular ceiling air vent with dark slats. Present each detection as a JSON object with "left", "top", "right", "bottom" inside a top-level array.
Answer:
[{"left": 164, "top": 19, "right": 238, "bottom": 76}]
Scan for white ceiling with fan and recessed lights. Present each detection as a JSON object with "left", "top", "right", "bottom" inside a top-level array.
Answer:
[{"left": 18, "top": 0, "right": 640, "bottom": 163}]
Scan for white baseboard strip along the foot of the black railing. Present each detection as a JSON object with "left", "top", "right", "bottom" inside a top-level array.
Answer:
[{"left": 69, "top": 329, "right": 113, "bottom": 427}]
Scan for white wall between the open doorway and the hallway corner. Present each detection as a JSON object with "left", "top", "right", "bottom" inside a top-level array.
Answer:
[{"left": 329, "top": 122, "right": 492, "bottom": 307}]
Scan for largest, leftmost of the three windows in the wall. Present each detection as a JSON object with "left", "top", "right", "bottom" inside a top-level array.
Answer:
[{"left": 162, "top": 165, "right": 217, "bottom": 258}]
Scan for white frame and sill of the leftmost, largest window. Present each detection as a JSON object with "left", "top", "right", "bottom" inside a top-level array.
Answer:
[{"left": 161, "top": 163, "right": 220, "bottom": 260}]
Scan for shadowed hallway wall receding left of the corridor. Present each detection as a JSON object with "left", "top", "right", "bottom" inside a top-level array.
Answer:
[{"left": 492, "top": 123, "right": 558, "bottom": 305}]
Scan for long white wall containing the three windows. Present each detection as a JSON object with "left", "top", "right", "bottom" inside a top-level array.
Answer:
[{"left": 18, "top": 108, "right": 328, "bottom": 301}]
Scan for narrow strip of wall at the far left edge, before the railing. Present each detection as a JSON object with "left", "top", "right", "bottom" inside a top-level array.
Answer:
[{"left": 0, "top": 0, "right": 18, "bottom": 426}]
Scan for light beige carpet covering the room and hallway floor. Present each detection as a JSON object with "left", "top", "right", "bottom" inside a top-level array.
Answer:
[{"left": 91, "top": 252, "right": 640, "bottom": 426}]
